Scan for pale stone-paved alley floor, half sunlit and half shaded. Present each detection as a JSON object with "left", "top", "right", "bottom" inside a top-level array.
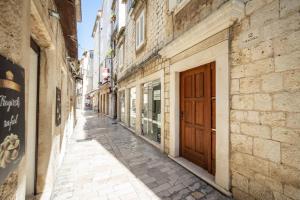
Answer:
[{"left": 52, "top": 113, "right": 230, "bottom": 200}]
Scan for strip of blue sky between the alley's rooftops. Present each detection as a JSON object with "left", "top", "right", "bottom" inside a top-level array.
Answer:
[{"left": 77, "top": 0, "right": 102, "bottom": 58}]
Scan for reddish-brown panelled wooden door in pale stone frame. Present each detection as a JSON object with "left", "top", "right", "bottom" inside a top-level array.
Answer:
[{"left": 180, "top": 63, "right": 215, "bottom": 174}]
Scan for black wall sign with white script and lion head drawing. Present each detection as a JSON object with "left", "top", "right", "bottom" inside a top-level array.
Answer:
[{"left": 0, "top": 56, "right": 25, "bottom": 184}]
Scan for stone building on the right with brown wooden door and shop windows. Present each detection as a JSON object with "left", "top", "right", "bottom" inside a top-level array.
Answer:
[{"left": 113, "top": 0, "right": 300, "bottom": 200}]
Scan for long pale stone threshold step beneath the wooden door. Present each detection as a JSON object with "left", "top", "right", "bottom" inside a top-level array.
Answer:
[{"left": 168, "top": 155, "right": 232, "bottom": 197}]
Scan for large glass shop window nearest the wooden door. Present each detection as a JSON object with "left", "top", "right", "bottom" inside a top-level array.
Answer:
[{"left": 142, "top": 80, "right": 161, "bottom": 143}]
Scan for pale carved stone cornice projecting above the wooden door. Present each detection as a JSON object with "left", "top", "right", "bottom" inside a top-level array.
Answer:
[{"left": 159, "top": 0, "right": 245, "bottom": 58}]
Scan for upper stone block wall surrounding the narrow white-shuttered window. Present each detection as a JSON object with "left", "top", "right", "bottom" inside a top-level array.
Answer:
[{"left": 119, "top": 0, "right": 171, "bottom": 77}]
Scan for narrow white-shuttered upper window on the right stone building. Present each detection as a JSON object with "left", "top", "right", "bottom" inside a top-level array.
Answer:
[{"left": 135, "top": 11, "right": 145, "bottom": 49}]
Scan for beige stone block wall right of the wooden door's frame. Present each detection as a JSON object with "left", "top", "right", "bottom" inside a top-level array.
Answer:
[{"left": 230, "top": 0, "right": 300, "bottom": 200}]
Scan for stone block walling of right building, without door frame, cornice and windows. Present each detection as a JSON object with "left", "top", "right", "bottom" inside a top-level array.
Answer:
[{"left": 119, "top": 0, "right": 300, "bottom": 200}]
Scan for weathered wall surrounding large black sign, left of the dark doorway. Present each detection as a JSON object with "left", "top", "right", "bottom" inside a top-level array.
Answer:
[{"left": 0, "top": 0, "right": 30, "bottom": 200}]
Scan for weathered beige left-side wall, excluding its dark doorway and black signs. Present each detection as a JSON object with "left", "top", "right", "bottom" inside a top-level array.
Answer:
[{"left": 0, "top": 0, "right": 75, "bottom": 200}]
